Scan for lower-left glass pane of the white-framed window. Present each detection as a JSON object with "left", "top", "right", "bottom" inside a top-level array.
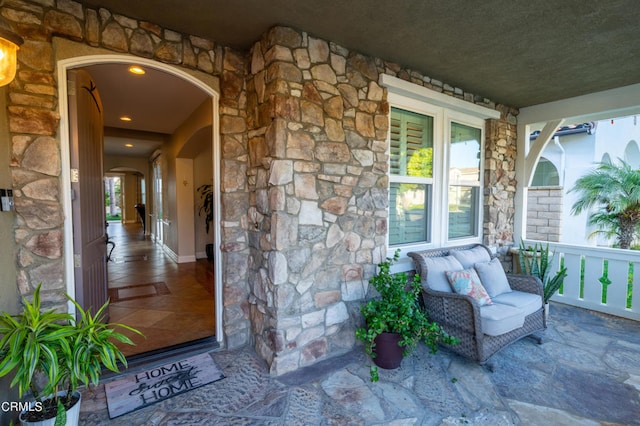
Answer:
[{"left": 389, "top": 182, "right": 431, "bottom": 245}]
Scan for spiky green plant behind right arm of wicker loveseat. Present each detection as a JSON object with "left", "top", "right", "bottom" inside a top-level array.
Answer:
[{"left": 518, "top": 241, "right": 567, "bottom": 303}]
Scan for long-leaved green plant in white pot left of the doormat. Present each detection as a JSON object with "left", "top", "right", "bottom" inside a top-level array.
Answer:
[{"left": 0, "top": 285, "right": 141, "bottom": 425}]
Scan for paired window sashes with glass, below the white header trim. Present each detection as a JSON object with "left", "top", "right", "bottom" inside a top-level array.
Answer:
[{"left": 389, "top": 100, "right": 484, "bottom": 247}]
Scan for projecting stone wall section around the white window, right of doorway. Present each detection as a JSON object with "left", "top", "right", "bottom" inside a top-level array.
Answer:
[{"left": 242, "top": 27, "right": 515, "bottom": 374}]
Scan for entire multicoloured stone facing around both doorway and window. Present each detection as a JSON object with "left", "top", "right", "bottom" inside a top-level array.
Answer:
[{"left": 1, "top": 0, "right": 517, "bottom": 374}]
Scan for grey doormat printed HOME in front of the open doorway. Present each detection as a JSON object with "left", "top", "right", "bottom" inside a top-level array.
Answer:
[{"left": 104, "top": 353, "right": 224, "bottom": 419}]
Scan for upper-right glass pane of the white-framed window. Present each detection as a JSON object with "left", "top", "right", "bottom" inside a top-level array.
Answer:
[{"left": 449, "top": 122, "right": 482, "bottom": 184}]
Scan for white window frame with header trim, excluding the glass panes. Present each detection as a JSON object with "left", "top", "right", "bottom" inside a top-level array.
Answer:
[{"left": 380, "top": 74, "right": 500, "bottom": 271}]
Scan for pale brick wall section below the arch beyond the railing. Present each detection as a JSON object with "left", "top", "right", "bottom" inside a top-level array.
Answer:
[{"left": 527, "top": 186, "right": 563, "bottom": 242}]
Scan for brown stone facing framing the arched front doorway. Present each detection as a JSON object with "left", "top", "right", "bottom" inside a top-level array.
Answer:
[{"left": 5, "top": 0, "right": 249, "bottom": 346}]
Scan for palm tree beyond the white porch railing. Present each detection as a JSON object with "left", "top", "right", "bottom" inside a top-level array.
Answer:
[{"left": 569, "top": 159, "right": 640, "bottom": 249}]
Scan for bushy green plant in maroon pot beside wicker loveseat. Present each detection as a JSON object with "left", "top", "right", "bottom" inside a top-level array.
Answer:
[{"left": 356, "top": 249, "right": 458, "bottom": 382}]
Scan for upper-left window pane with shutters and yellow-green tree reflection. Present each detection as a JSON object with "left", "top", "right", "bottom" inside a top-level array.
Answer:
[{"left": 390, "top": 108, "right": 433, "bottom": 178}]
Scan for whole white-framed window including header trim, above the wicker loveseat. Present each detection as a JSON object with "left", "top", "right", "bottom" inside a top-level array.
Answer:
[{"left": 380, "top": 74, "right": 500, "bottom": 262}]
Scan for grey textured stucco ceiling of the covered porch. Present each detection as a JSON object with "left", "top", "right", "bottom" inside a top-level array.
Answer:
[{"left": 81, "top": 0, "right": 640, "bottom": 107}]
